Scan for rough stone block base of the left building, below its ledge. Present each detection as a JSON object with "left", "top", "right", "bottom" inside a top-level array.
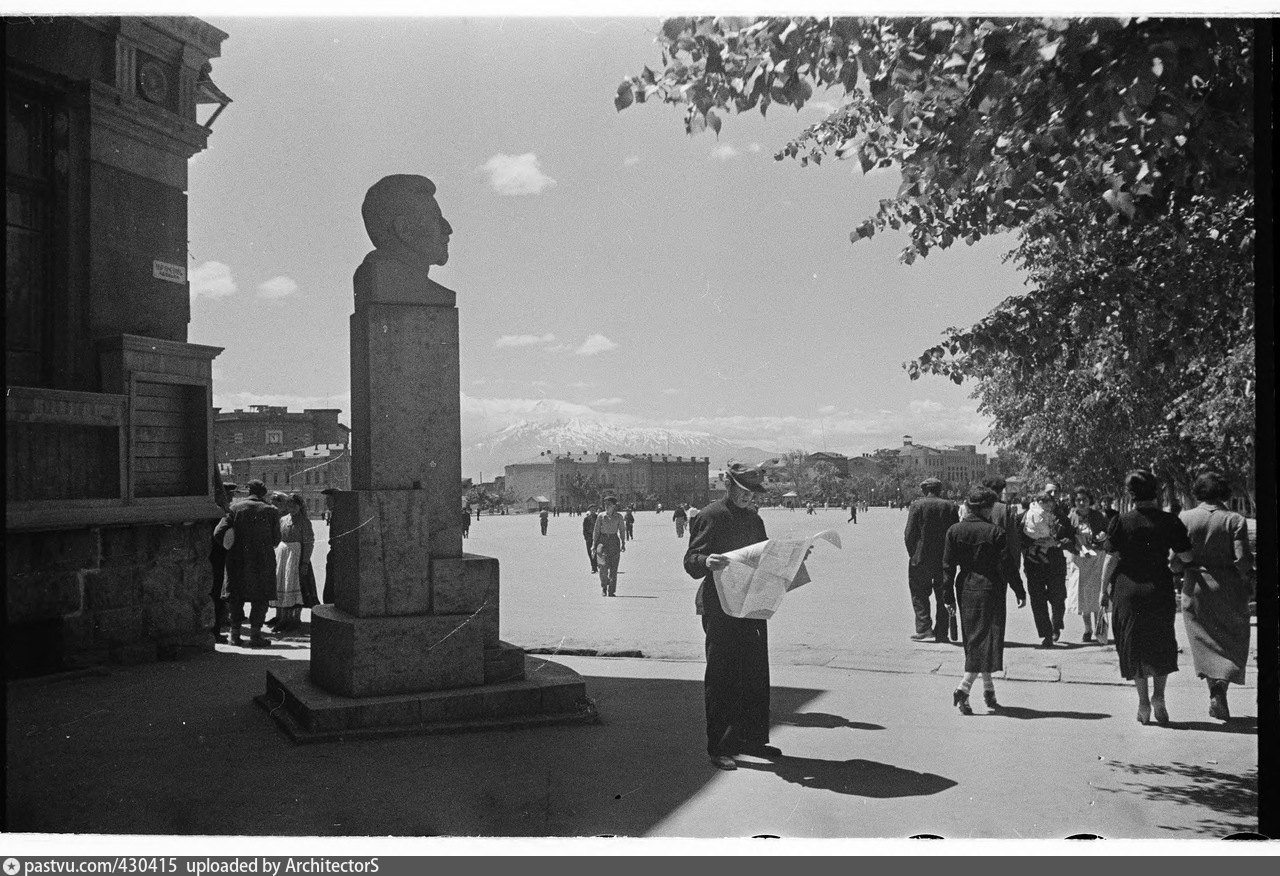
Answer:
[{"left": 5, "top": 523, "right": 214, "bottom": 677}]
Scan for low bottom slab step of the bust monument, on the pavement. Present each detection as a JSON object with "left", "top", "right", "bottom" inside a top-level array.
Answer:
[{"left": 263, "top": 645, "right": 599, "bottom": 743}]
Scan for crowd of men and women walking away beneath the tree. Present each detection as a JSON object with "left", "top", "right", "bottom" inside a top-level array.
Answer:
[{"left": 905, "top": 470, "right": 1253, "bottom": 724}]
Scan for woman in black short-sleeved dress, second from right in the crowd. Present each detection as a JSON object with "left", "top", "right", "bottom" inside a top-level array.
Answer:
[{"left": 1102, "top": 470, "right": 1192, "bottom": 724}]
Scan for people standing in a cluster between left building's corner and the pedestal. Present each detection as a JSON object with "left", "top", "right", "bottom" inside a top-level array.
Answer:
[{"left": 210, "top": 478, "right": 319, "bottom": 648}]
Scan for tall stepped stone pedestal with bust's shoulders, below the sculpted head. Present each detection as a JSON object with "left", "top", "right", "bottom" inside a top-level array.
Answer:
[{"left": 267, "top": 181, "right": 595, "bottom": 740}]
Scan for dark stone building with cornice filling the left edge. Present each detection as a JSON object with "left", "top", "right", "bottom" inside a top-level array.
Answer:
[{"left": 4, "top": 15, "right": 229, "bottom": 677}]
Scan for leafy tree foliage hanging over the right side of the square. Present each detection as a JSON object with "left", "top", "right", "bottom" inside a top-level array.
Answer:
[{"left": 624, "top": 18, "right": 1256, "bottom": 492}]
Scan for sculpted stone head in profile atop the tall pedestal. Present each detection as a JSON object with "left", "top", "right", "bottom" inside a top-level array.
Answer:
[{"left": 360, "top": 173, "right": 453, "bottom": 269}]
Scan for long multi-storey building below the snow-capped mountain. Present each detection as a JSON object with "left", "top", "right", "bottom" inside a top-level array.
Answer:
[{"left": 506, "top": 452, "right": 710, "bottom": 510}]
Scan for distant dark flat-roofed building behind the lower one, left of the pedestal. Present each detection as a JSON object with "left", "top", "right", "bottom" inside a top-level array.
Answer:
[{"left": 214, "top": 405, "right": 351, "bottom": 462}]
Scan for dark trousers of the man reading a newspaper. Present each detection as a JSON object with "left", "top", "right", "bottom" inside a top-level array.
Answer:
[{"left": 703, "top": 612, "right": 769, "bottom": 757}]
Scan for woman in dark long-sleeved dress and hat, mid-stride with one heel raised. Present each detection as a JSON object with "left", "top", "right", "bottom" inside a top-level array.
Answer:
[{"left": 942, "top": 487, "right": 1027, "bottom": 715}]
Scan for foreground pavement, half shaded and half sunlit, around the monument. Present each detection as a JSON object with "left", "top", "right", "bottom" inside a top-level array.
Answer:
[{"left": 6, "top": 650, "right": 1257, "bottom": 839}]
